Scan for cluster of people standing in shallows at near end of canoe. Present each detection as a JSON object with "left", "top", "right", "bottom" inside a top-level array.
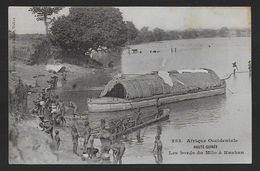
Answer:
[{"left": 71, "top": 119, "right": 125, "bottom": 164}]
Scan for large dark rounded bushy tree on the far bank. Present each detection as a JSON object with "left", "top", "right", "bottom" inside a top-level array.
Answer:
[{"left": 50, "top": 7, "right": 127, "bottom": 57}]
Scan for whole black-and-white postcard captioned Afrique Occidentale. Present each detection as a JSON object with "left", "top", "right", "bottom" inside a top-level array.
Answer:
[{"left": 8, "top": 6, "right": 253, "bottom": 165}]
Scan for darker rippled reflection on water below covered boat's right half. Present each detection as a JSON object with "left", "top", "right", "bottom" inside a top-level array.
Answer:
[{"left": 168, "top": 95, "right": 226, "bottom": 129}]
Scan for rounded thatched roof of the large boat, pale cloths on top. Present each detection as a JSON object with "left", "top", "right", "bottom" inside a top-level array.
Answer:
[{"left": 100, "top": 69, "right": 222, "bottom": 99}]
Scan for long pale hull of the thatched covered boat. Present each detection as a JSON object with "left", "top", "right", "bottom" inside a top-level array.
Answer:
[{"left": 87, "top": 87, "right": 226, "bottom": 113}]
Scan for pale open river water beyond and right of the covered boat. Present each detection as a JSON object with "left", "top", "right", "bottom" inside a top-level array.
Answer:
[{"left": 61, "top": 37, "right": 252, "bottom": 164}]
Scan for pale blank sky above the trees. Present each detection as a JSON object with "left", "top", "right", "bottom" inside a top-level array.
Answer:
[{"left": 8, "top": 7, "right": 251, "bottom": 34}]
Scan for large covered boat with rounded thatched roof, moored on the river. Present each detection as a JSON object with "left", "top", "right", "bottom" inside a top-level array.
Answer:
[{"left": 87, "top": 69, "right": 226, "bottom": 112}]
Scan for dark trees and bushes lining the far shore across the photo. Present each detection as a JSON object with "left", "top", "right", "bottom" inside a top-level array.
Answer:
[{"left": 8, "top": 7, "right": 251, "bottom": 67}]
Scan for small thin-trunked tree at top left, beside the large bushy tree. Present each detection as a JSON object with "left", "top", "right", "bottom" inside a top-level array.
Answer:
[{"left": 29, "top": 6, "right": 62, "bottom": 36}]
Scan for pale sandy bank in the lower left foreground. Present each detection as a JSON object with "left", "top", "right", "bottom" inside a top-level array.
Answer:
[{"left": 9, "top": 117, "right": 99, "bottom": 164}]
